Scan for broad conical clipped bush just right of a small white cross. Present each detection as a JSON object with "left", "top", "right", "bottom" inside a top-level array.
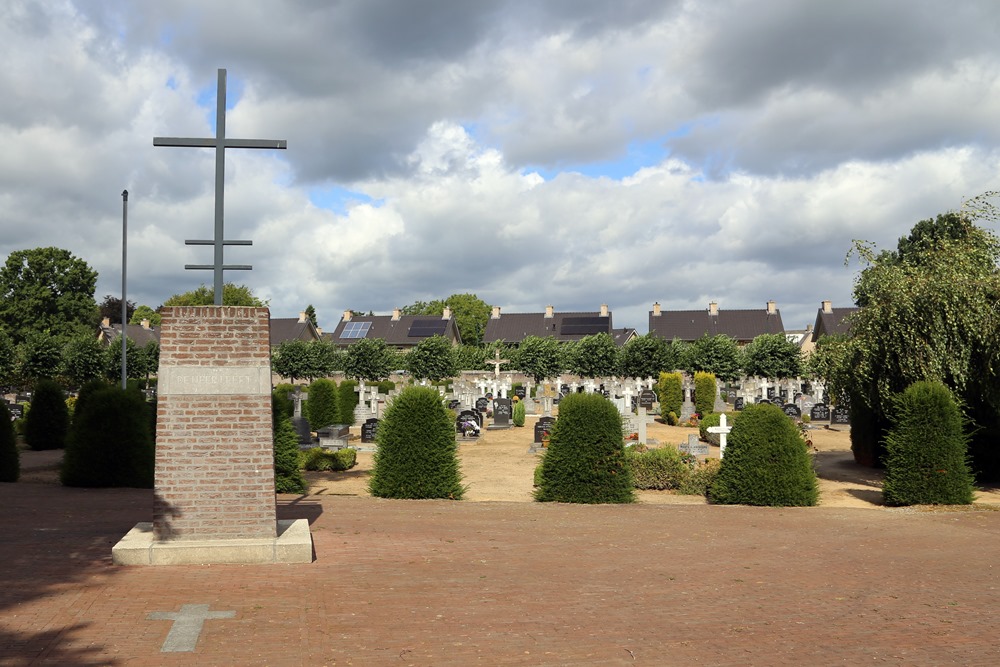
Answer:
[{"left": 708, "top": 403, "right": 819, "bottom": 507}]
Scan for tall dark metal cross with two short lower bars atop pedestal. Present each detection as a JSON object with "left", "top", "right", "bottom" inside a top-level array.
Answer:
[{"left": 153, "top": 69, "right": 288, "bottom": 306}]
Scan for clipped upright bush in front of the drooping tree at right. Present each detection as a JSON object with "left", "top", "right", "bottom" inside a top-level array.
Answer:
[{"left": 882, "top": 382, "right": 973, "bottom": 505}]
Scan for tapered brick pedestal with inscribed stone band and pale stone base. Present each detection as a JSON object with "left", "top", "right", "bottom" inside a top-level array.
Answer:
[{"left": 112, "top": 306, "right": 312, "bottom": 565}]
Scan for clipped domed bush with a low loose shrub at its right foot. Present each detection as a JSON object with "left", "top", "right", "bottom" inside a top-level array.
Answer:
[{"left": 535, "top": 394, "right": 635, "bottom": 503}]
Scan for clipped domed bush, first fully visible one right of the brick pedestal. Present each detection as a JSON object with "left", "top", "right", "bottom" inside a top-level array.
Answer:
[{"left": 368, "top": 385, "right": 465, "bottom": 500}]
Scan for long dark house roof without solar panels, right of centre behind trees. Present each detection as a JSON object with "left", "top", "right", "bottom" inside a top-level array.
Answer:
[{"left": 649, "top": 307, "right": 785, "bottom": 343}]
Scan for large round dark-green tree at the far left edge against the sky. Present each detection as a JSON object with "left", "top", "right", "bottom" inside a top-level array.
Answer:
[{"left": 0, "top": 248, "right": 97, "bottom": 343}]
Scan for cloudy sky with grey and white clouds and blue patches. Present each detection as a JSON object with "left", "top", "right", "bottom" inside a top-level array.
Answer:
[{"left": 0, "top": 0, "right": 1000, "bottom": 332}]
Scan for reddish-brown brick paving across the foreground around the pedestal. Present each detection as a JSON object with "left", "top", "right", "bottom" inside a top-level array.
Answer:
[{"left": 0, "top": 483, "right": 1000, "bottom": 667}]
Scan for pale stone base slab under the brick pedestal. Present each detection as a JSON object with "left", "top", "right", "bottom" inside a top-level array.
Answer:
[{"left": 111, "top": 519, "right": 312, "bottom": 565}]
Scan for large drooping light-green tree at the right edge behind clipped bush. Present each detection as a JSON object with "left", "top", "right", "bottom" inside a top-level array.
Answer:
[{"left": 845, "top": 206, "right": 1000, "bottom": 479}]
